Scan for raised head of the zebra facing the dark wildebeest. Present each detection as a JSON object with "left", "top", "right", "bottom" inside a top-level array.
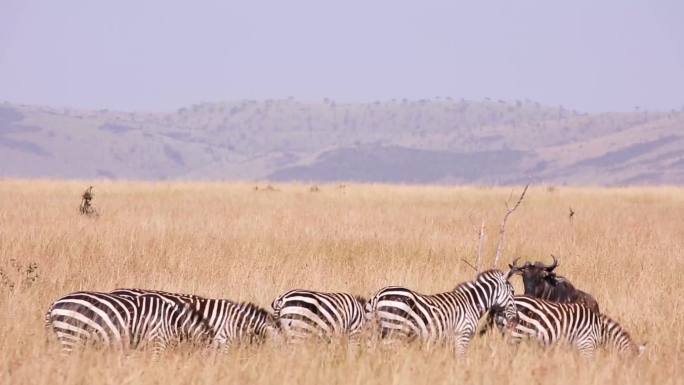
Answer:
[{"left": 475, "top": 270, "right": 518, "bottom": 324}]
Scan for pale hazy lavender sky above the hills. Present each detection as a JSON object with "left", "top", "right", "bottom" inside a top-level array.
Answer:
[{"left": 0, "top": 0, "right": 684, "bottom": 111}]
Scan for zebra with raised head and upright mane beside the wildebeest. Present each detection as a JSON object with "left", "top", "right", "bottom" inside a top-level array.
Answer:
[{"left": 366, "top": 270, "right": 516, "bottom": 353}]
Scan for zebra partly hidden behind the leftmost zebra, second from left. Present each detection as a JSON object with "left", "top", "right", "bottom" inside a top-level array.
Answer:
[{"left": 111, "top": 289, "right": 276, "bottom": 352}]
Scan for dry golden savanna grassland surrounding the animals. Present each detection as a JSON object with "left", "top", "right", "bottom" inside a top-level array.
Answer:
[{"left": 0, "top": 180, "right": 684, "bottom": 385}]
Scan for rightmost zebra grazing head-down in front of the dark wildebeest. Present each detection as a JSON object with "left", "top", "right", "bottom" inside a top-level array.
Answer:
[{"left": 494, "top": 295, "right": 645, "bottom": 357}]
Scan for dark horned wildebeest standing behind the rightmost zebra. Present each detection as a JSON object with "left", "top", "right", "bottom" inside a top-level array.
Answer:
[{"left": 508, "top": 255, "right": 599, "bottom": 313}]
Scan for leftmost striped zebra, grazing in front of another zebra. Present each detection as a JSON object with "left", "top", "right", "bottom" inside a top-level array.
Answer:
[{"left": 45, "top": 292, "right": 214, "bottom": 357}]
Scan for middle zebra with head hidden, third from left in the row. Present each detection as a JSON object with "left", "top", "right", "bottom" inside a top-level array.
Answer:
[{"left": 271, "top": 289, "right": 366, "bottom": 341}]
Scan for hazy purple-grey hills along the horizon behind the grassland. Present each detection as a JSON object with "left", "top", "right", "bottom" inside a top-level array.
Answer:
[{"left": 0, "top": 98, "right": 684, "bottom": 185}]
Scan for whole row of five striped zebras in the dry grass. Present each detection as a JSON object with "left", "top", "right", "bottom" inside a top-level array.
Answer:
[{"left": 45, "top": 263, "right": 642, "bottom": 357}]
